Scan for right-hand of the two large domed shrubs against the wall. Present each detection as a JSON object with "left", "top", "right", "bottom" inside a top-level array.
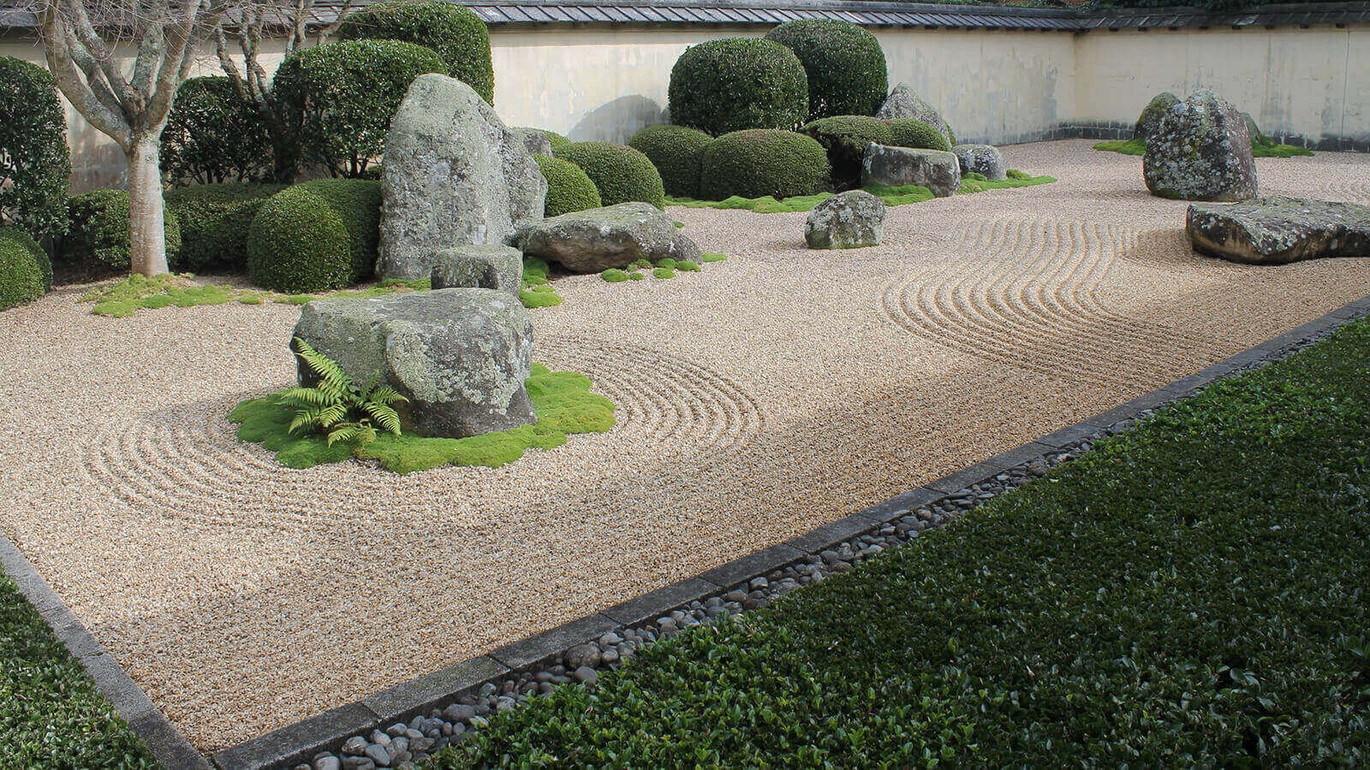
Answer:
[{"left": 766, "top": 19, "right": 889, "bottom": 121}]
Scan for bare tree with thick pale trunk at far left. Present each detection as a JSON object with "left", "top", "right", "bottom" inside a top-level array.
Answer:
[{"left": 33, "top": 0, "right": 227, "bottom": 275}]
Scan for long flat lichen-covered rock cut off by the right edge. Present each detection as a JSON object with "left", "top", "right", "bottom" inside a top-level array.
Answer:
[{"left": 1185, "top": 196, "right": 1370, "bottom": 264}]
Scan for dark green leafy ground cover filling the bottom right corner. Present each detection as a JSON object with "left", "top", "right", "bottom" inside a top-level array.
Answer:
[{"left": 441, "top": 316, "right": 1370, "bottom": 767}]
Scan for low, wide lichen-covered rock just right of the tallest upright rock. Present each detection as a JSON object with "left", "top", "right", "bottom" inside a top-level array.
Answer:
[{"left": 518, "top": 203, "right": 701, "bottom": 273}]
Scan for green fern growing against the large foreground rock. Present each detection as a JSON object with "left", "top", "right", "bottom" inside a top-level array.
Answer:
[{"left": 281, "top": 337, "right": 408, "bottom": 447}]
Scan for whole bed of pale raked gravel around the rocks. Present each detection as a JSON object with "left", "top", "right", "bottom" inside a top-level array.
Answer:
[{"left": 0, "top": 141, "right": 1370, "bottom": 749}]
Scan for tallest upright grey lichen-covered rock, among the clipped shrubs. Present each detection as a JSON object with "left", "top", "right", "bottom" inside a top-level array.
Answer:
[{"left": 377, "top": 74, "right": 547, "bottom": 281}]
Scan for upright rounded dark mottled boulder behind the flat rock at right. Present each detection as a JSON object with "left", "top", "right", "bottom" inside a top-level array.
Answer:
[{"left": 1141, "top": 90, "right": 1256, "bottom": 201}]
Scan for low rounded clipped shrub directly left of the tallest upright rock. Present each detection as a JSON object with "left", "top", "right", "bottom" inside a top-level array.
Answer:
[{"left": 248, "top": 179, "right": 381, "bottom": 293}]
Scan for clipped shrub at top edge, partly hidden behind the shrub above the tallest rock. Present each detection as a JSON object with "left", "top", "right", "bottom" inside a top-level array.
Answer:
[{"left": 338, "top": 0, "right": 495, "bottom": 104}]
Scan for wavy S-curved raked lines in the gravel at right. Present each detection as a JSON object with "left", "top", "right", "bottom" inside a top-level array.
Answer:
[{"left": 884, "top": 219, "right": 1225, "bottom": 384}]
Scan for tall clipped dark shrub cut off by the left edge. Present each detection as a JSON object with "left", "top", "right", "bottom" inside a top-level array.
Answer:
[{"left": 0, "top": 56, "right": 71, "bottom": 238}]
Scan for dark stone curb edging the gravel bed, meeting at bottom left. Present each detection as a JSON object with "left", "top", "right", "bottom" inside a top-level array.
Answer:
[{"left": 10, "top": 296, "right": 1370, "bottom": 770}]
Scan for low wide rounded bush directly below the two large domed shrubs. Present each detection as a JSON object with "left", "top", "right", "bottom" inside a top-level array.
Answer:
[{"left": 699, "top": 129, "right": 830, "bottom": 200}]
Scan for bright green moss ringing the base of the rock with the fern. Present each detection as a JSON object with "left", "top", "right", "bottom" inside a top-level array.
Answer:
[{"left": 229, "top": 363, "right": 614, "bottom": 474}]
